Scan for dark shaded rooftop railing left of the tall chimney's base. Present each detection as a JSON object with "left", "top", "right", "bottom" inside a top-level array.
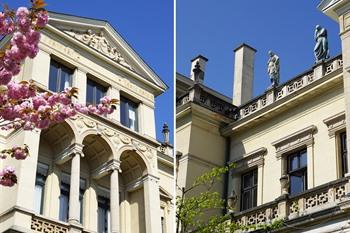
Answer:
[{"left": 176, "top": 83, "right": 238, "bottom": 120}]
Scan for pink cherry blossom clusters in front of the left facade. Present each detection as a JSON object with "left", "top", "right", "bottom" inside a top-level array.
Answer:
[{"left": 0, "top": 1, "right": 116, "bottom": 186}]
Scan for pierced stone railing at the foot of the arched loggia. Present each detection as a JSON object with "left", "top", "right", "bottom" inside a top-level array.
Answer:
[{"left": 31, "top": 215, "right": 69, "bottom": 233}]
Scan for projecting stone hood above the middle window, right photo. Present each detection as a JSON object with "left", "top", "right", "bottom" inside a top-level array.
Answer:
[{"left": 271, "top": 125, "right": 317, "bottom": 159}]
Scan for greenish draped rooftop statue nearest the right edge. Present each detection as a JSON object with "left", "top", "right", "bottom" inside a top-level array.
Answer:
[{"left": 314, "top": 25, "right": 329, "bottom": 63}]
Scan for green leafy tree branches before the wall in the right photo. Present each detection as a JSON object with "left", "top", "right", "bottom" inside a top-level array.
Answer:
[{"left": 176, "top": 164, "right": 283, "bottom": 233}]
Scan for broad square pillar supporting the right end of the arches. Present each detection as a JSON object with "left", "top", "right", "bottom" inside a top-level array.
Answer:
[{"left": 143, "top": 175, "right": 162, "bottom": 233}]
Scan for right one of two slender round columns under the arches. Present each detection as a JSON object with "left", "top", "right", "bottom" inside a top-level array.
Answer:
[{"left": 110, "top": 166, "right": 120, "bottom": 233}]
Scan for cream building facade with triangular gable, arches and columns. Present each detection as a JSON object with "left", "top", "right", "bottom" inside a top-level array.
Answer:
[{"left": 0, "top": 12, "right": 174, "bottom": 233}]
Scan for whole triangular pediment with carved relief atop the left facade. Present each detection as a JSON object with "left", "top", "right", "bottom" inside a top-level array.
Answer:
[{"left": 49, "top": 12, "right": 167, "bottom": 94}]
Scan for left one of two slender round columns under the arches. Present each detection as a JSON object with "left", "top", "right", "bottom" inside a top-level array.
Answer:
[{"left": 68, "top": 152, "right": 80, "bottom": 224}]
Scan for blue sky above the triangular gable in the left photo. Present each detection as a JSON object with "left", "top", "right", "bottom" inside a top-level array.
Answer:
[{"left": 10, "top": 0, "right": 174, "bottom": 144}]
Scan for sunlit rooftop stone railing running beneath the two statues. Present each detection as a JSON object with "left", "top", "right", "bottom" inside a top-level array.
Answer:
[{"left": 237, "top": 55, "right": 343, "bottom": 119}]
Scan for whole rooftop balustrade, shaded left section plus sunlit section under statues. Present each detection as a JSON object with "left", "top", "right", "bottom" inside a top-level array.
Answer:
[{"left": 176, "top": 55, "right": 343, "bottom": 123}]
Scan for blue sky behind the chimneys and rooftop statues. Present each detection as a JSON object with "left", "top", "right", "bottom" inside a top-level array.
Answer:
[{"left": 176, "top": 0, "right": 341, "bottom": 100}]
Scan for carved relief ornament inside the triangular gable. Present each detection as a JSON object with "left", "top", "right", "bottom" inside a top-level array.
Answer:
[{"left": 65, "top": 29, "right": 133, "bottom": 70}]
